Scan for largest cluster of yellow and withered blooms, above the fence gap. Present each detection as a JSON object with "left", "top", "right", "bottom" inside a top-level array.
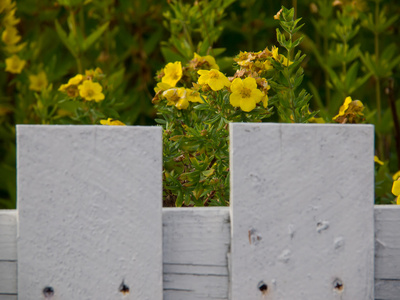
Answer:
[{"left": 153, "top": 49, "right": 273, "bottom": 112}]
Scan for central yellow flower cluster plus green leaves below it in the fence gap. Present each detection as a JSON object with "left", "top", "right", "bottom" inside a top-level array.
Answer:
[{"left": 153, "top": 49, "right": 273, "bottom": 206}]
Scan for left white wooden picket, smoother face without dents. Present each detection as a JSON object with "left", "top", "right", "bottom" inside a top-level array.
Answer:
[{"left": 17, "top": 125, "right": 162, "bottom": 300}]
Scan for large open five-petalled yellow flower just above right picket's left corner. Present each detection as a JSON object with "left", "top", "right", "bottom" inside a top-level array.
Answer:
[{"left": 229, "top": 77, "right": 268, "bottom": 112}]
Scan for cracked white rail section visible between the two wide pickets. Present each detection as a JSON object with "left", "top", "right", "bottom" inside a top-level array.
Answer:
[{"left": 163, "top": 207, "right": 230, "bottom": 300}]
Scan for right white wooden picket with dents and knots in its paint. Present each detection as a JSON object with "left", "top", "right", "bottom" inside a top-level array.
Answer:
[{"left": 230, "top": 123, "right": 374, "bottom": 300}]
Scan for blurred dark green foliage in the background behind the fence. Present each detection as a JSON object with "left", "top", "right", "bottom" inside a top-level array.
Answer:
[{"left": 0, "top": 0, "right": 400, "bottom": 208}]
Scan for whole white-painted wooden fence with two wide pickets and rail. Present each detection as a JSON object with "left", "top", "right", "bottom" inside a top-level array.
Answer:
[{"left": 0, "top": 124, "right": 400, "bottom": 300}]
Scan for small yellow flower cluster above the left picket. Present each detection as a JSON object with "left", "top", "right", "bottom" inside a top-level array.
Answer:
[{"left": 58, "top": 68, "right": 104, "bottom": 102}]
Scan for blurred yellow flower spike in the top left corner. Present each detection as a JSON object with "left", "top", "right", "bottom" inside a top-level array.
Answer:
[{"left": 0, "top": 0, "right": 26, "bottom": 74}]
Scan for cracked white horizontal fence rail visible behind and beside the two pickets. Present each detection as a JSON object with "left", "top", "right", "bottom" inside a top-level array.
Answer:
[{"left": 0, "top": 205, "right": 400, "bottom": 300}]
